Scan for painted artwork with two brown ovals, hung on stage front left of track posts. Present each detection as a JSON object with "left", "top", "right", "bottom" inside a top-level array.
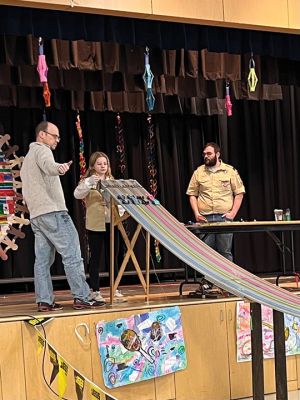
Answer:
[{"left": 96, "top": 306, "right": 187, "bottom": 388}]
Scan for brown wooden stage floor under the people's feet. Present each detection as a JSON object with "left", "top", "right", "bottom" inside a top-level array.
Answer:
[{"left": 0, "top": 277, "right": 300, "bottom": 322}]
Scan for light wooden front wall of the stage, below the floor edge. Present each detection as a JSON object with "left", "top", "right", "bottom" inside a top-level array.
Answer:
[{"left": 0, "top": 299, "right": 300, "bottom": 400}]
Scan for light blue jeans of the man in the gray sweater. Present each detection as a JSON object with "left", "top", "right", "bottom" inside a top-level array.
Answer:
[{"left": 31, "top": 211, "right": 89, "bottom": 304}]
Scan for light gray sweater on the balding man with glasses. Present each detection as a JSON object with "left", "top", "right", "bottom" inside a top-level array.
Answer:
[{"left": 21, "top": 142, "right": 67, "bottom": 219}]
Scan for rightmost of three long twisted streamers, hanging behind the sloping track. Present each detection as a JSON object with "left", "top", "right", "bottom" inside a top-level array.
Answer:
[{"left": 146, "top": 114, "right": 161, "bottom": 263}]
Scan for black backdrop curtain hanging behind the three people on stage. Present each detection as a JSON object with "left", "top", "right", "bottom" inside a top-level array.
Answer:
[{"left": 0, "top": 86, "right": 300, "bottom": 278}]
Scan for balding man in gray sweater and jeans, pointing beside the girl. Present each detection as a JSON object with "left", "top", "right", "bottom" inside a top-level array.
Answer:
[{"left": 21, "top": 121, "right": 105, "bottom": 311}]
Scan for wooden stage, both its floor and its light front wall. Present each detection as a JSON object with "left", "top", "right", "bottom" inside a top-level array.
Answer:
[{"left": 0, "top": 282, "right": 300, "bottom": 400}]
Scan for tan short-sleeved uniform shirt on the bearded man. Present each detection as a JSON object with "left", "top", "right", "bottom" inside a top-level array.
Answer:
[{"left": 186, "top": 161, "right": 245, "bottom": 215}]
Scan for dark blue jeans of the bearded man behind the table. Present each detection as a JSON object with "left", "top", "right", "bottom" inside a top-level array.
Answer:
[{"left": 199, "top": 214, "right": 233, "bottom": 261}]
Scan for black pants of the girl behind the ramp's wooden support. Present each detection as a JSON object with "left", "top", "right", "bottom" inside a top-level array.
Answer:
[{"left": 87, "top": 224, "right": 119, "bottom": 291}]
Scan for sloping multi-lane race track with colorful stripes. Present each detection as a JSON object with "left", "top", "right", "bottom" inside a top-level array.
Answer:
[{"left": 102, "top": 180, "right": 300, "bottom": 317}]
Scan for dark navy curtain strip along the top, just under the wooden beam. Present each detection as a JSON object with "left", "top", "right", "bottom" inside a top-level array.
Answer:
[{"left": 0, "top": 6, "right": 300, "bottom": 60}]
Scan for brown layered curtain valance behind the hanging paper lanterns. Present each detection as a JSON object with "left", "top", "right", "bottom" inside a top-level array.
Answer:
[{"left": 0, "top": 35, "right": 282, "bottom": 115}]
